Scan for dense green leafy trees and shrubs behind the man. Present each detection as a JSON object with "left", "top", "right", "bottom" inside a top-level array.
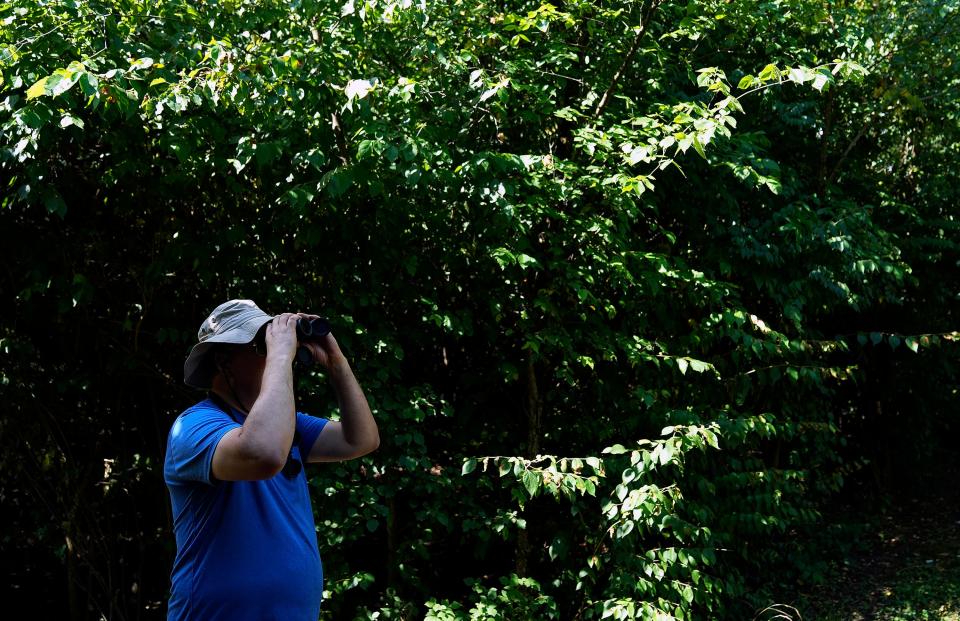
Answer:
[{"left": 0, "top": 0, "right": 960, "bottom": 620}]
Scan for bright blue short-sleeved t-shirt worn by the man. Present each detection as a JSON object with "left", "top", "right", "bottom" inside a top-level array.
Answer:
[{"left": 163, "top": 399, "right": 327, "bottom": 621}]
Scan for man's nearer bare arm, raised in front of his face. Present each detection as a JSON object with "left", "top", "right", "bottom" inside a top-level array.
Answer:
[{"left": 212, "top": 313, "right": 297, "bottom": 481}]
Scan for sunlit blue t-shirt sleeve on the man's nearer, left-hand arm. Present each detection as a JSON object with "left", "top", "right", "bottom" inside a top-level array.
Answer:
[{"left": 165, "top": 407, "right": 240, "bottom": 484}]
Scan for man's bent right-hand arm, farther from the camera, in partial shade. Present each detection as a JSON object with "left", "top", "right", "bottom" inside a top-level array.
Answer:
[{"left": 307, "top": 334, "right": 380, "bottom": 462}]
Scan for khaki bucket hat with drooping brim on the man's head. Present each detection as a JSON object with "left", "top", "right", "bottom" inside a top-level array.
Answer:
[{"left": 183, "top": 300, "right": 273, "bottom": 390}]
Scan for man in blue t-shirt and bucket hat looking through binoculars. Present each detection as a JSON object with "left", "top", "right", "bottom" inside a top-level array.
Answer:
[{"left": 164, "top": 300, "right": 380, "bottom": 621}]
